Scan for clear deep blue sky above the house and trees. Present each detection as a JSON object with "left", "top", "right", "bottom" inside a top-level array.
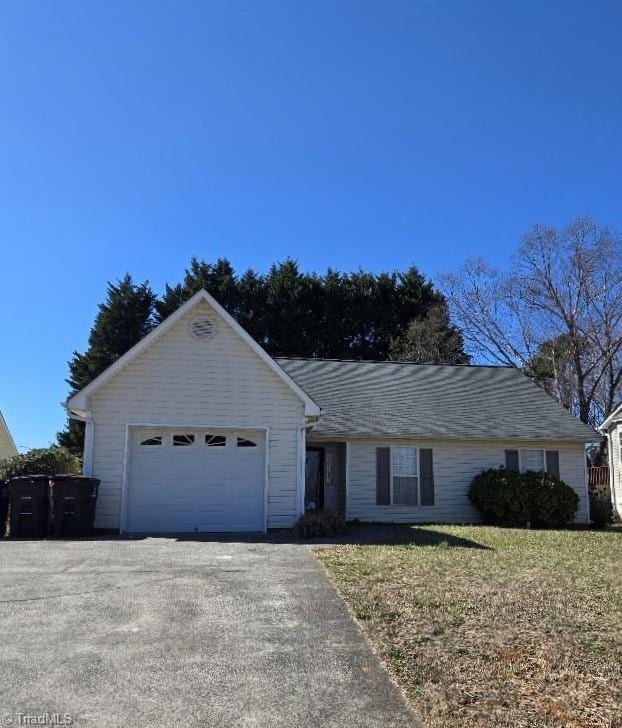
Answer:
[{"left": 0, "top": 0, "right": 622, "bottom": 447}]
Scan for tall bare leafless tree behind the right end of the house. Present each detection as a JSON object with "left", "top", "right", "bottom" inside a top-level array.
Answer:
[{"left": 441, "top": 218, "right": 622, "bottom": 425}]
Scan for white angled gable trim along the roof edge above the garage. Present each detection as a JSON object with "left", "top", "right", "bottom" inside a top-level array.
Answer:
[{"left": 65, "top": 289, "right": 321, "bottom": 416}]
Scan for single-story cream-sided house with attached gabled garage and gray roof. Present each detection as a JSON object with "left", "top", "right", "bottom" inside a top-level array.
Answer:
[{"left": 66, "top": 291, "right": 599, "bottom": 532}]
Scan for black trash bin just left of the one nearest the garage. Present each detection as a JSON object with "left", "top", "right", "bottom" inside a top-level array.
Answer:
[{"left": 9, "top": 475, "right": 50, "bottom": 538}]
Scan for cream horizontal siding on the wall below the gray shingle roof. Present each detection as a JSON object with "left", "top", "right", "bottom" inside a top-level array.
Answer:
[{"left": 347, "top": 439, "right": 587, "bottom": 523}]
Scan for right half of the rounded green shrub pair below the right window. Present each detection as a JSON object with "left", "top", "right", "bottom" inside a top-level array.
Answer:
[{"left": 522, "top": 471, "right": 579, "bottom": 528}]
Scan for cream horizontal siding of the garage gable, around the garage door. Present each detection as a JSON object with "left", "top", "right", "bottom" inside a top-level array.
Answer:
[{"left": 90, "top": 302, "right": 304, "bottom": 529}]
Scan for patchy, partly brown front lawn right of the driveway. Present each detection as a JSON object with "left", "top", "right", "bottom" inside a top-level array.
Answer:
[{"left": 316, "top": 526, "right": 622, "bottom": 727}]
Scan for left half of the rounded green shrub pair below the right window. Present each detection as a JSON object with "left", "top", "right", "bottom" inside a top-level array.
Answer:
[{"left": 469, "top": 468, "right": 529, "bottom": 527}]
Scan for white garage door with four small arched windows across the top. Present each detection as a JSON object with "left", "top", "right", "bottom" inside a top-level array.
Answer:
[{"left": 127, "top": 428, "right": 266, "bottom": 533}]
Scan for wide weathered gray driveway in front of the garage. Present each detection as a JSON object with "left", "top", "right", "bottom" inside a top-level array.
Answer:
[{"left": 0, "top": 538, "right": 416, "bottom": 728}]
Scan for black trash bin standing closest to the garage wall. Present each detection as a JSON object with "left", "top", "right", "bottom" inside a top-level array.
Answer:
[{"left": 50, "top": 475, "right": 99, "bottom": 538}]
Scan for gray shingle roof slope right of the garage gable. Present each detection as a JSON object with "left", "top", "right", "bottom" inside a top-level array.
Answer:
[{"left": 276, "top": 359, "right": 599, "bottom": 441}]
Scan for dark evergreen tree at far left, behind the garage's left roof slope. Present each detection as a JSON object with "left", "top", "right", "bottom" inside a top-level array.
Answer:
[{"left": 57, "top": 274, "right": 156, "bottom": 457}]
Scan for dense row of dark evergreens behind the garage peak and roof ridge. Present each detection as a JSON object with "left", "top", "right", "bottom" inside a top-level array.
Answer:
[{"left": 156, "top": 258, "right": 468, "bottom": 362}]
